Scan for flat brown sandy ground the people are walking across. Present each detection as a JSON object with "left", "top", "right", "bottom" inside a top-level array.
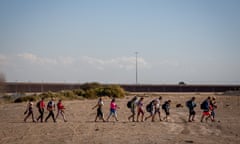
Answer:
[{"left": 0, "top": 94, "right": 240, "bottom": 144}]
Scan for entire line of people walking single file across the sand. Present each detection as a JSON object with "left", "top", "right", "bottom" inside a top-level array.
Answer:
[{"left": 24, "top": 96, "right": 217, "bottom": 122}]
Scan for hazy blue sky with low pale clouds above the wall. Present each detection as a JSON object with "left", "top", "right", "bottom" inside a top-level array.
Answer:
[{"left": 0, "top": 0, "right": 240, "bottom": 84}]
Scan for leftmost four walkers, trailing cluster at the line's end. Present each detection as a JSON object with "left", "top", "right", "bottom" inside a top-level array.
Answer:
[{"left": 24, "top": 98, "right": 67, "bottom": 122}]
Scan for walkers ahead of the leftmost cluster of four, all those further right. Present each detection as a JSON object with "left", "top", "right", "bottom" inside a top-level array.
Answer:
[{"left": 92, "top": 96, "right": 217, "bottom": 122}]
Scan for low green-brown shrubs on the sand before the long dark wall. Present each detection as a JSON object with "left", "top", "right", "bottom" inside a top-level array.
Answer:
[{"left": 11, "top": 83, "right": 125, "bottom": 103}]
